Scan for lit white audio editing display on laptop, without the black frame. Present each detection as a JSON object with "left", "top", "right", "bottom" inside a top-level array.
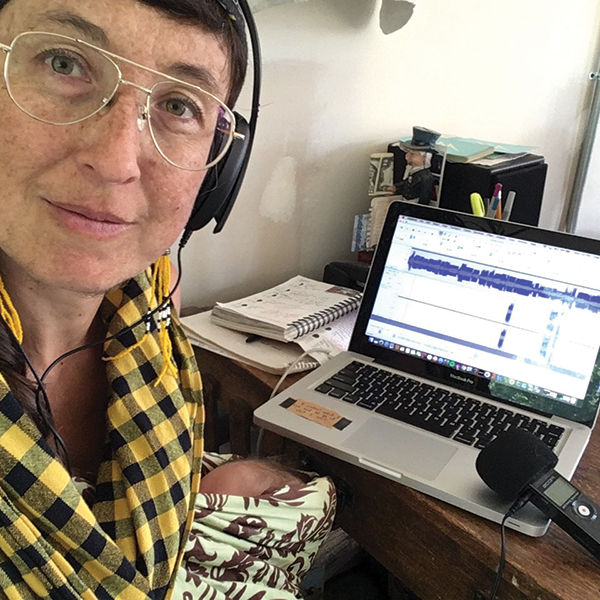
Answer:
[{"left": 367, "top": 217, "right": 600, "bottom": 405}]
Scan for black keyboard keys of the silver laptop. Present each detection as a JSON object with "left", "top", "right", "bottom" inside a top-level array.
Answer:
[{"left": 316, "top": 361, "right": 564, "bottom": 448}]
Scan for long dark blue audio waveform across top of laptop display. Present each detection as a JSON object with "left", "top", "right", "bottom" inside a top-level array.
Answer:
[{"left": 408, "top": 252, "right": 600, "bottom": 312}]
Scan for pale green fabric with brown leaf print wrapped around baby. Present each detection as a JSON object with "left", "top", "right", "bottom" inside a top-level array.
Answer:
[{"left": 173, "top": 453, "right": 336, "bottom": 600}]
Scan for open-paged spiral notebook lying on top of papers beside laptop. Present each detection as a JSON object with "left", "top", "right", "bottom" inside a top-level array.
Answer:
[{"left": 211, "top": 275, "right": 361, "bottom": 342}]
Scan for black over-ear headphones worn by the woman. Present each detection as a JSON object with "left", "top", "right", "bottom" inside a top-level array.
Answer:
[{"left": 183, "top": 0, "right": 261, "bottom": 240}]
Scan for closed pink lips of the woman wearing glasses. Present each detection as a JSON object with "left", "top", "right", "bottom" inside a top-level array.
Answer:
[{"left": 47, "top": 200, "right": 133, "bottom": 239}]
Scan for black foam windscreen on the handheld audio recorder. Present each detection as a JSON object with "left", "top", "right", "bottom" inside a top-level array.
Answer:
[{"left": 475, "top": 428, "right": 558, "bottom": 501}]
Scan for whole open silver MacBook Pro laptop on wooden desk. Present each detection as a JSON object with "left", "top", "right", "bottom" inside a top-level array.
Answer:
[{"left": 254, "top": 202, "right": 600, "bottom": 536}]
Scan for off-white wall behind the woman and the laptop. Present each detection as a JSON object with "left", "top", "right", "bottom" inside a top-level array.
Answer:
[{"left": 183, "top": 0, "right": 600, "bottom": 306}]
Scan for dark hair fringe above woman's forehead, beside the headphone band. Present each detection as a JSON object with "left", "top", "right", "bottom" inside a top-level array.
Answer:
[{"left": 0, "top": 0, "right": 248, "bottom": 107}]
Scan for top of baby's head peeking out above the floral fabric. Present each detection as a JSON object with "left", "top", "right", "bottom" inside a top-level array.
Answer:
[{"left": 200, "top": 458, "right": 310, "bottom": 497}]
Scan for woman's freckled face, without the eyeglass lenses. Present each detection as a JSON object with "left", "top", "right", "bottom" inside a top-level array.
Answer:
[{"left": 0, "top": 0, "right": 229, "bottom": 294}]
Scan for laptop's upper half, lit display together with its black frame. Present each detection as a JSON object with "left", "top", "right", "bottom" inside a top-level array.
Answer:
[{"left": 351, "top": 203, "right": 600, "bottom": 422}]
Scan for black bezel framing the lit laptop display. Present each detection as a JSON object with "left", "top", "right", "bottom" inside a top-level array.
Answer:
[{"left": 349, "top": 201, "right": 600, "bottom": 427}]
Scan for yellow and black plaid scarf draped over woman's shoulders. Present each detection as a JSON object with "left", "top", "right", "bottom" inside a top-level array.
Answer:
[{"left": 0, "top": 271, "right": 203, "bottom": 600}]
